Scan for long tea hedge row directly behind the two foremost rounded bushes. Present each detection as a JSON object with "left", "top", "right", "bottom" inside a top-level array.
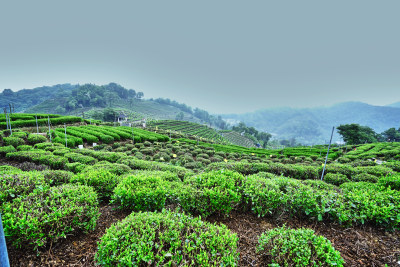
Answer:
[{"left": 112, "top": 170, "right": 400, "bottom": 229}]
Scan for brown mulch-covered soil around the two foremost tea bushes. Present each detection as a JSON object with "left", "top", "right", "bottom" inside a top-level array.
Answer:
[{"left": 7, "top": 205, "right": 400, "bottom": 266}]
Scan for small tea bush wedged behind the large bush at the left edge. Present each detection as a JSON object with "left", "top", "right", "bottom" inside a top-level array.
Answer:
[{"left": 70, "top": 169, "right": 120, "bottom": 201}]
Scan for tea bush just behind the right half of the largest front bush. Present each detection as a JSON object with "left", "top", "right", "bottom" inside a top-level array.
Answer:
[{"left": 179, "top": 170, "right": 244, "bottom": 216}]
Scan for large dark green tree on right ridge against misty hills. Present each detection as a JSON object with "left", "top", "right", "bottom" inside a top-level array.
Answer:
[{"left": 337, "top": 123, "right": 379, "bottom": 145}]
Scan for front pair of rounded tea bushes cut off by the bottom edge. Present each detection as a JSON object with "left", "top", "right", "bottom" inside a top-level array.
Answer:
[{"left": 95, "top": 210, "right": 344, "bottom": 266}]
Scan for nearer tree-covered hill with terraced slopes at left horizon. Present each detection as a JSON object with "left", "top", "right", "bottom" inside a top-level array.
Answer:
[{"left": 4, "top": 83, "right": 226, "bottom": 129}]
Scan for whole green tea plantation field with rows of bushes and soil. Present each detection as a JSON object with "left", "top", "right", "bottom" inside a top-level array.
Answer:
[{"left": 0, "top": 120, "right": 400, "bottom": 266}]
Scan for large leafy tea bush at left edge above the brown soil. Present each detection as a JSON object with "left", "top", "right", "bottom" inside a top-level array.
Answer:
[{"left": 2, "top": 184, "right": 100, "bottom": 249}]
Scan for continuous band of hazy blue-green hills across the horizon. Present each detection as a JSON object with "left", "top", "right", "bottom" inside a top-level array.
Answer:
[{"left": 0, "top": 83, "right": 400, "bottom": 144}]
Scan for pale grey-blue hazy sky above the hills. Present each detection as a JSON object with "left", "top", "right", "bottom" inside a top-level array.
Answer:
[{"left": 0, "top": 0, "right": 400, "bottom": 113}]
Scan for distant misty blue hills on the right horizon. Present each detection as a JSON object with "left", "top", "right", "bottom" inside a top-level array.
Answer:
[{"left": 222, "top": 102, "right": 400, "bottom": 144}]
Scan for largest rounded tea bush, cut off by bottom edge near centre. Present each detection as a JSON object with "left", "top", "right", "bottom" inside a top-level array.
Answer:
[{"left": 95, "top": 210, "right": 239, "bottom": 266}]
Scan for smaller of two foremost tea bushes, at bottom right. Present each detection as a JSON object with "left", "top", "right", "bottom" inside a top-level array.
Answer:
[{"left": 257, "top": 226, "right": 344, "bottom": 266}]
